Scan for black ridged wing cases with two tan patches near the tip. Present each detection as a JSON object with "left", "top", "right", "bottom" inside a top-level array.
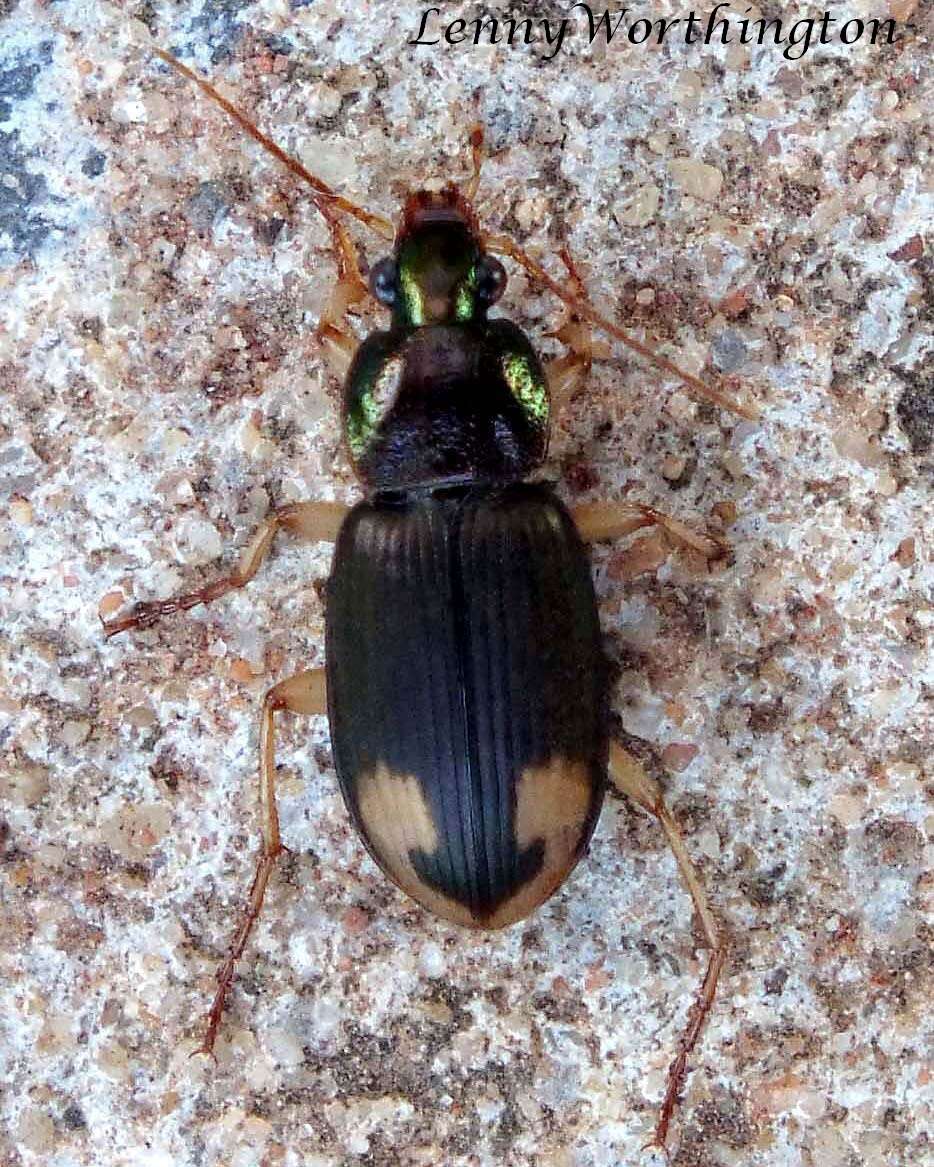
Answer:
[{"left": 326, "top": 485, "right": 607, "bottom": 928}]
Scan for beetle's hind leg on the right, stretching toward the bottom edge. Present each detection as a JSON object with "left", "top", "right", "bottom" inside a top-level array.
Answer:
[{"left": 609, "top": 742, "right": 729, "bottom": 1148}]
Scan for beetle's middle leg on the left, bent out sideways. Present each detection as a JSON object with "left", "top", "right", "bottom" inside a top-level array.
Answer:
[{"left": 104, "top": 502, "right": 347, "bottom": 637}]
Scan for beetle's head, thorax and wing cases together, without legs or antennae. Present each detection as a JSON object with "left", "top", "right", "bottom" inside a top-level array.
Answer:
[{"left": 326, "top": 188, "right": 607, "bottom": 928}]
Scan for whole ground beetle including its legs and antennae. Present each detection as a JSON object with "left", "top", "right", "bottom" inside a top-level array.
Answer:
[{"left": 105, "top": 41, "right": 754, "bottom": 1147}]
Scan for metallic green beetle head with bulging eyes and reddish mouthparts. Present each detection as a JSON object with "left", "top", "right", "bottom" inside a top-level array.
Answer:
[{"left": 370, "top": 187, "right": 506, "bottom": 328}]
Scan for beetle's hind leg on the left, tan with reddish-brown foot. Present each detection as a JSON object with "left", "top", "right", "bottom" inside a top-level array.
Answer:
[{"left": 193, "top": 669, "right": 327, "bottom": 1056}]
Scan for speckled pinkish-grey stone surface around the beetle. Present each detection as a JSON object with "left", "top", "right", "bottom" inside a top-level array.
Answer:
[{"left": 0, "top": 0, "right": 934, "bottom": 1167}]
